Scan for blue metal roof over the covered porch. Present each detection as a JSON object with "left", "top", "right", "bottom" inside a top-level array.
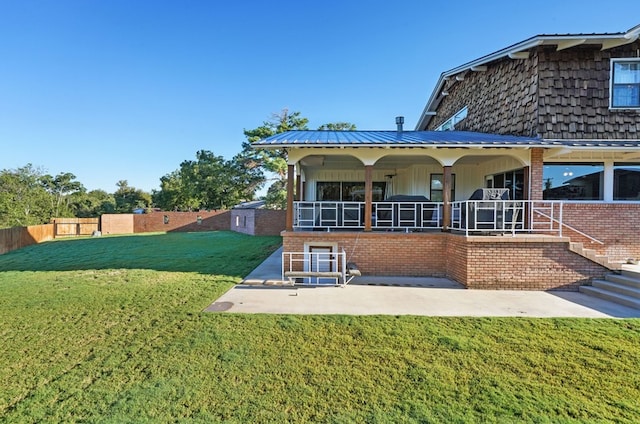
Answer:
[{"left": 253, "top": 131, "right": 560, "bottom": 148}]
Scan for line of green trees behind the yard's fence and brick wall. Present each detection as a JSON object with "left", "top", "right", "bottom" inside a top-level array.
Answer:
[{"left": 0, "top": 109, "right": 356, "bottom": 228}]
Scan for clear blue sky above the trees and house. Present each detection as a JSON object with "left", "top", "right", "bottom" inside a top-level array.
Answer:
[{"left": 0, "top": 0, "right": 640, "bottom": 192}]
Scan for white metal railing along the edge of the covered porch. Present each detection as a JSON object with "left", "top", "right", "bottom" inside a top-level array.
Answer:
[{"left": 293, "top": 200, "right": 563, "bottom": 236}]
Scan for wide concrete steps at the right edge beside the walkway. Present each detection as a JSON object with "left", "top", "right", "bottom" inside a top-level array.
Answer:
[{"left": 580, "top": 265, "right": 640, "bottom": 309}]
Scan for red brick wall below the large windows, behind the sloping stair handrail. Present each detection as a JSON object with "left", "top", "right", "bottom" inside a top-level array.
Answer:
[{"left": 562, "top": 203, "right": 640, "bottom": 262}]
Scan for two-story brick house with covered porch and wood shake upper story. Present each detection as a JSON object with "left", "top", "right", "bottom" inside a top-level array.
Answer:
[{"left": 256, "top": 22, "right": 640, "bottom": 290}]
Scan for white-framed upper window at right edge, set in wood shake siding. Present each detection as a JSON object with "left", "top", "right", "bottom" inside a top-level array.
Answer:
[{"left": 610, "top": 58, "right": 640, "bottom": 109}]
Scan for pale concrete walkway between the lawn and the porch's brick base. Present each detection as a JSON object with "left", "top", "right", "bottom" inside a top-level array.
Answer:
[{"left": 205, "top": 250, "right": 640, "bottom": 318}]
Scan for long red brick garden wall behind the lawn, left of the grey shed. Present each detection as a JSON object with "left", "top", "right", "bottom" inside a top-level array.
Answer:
[{"left": 133, "top": 211, "right": 231, "bottom": 233}]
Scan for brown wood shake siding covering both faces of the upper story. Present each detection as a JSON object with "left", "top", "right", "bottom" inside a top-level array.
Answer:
[{"left": 427, "top": 41, "right": 640, "bottom": 139}]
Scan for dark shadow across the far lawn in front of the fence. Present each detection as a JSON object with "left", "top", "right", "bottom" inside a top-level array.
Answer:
[{"left": 0, "top": 231, "right": 282, "bottom": 278}]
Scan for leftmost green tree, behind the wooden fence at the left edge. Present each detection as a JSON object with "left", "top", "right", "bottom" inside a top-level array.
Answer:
[{"left": 0, "top": 163, "right": 52, "bottom": 228}]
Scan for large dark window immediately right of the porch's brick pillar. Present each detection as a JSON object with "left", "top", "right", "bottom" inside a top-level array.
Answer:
[{"left": 542, "top": 163, "right": 604, "bottom": 200}]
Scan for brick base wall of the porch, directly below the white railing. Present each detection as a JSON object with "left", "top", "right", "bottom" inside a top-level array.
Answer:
[{"left": 283, "top": 232, "right": 609, "bottom": 291}]
